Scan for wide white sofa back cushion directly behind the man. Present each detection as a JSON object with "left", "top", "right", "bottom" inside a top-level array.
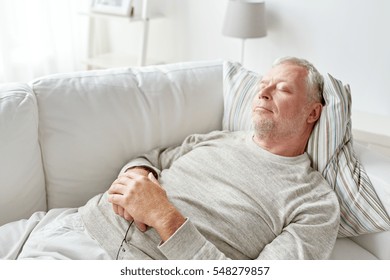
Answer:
[{"left": 31, "top": 61, "right": 223, "bottom": 209}]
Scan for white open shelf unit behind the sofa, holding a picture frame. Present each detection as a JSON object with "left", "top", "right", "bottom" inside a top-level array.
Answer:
[{"left": 81, "top": 0, "right": 162, "bottom": 69}]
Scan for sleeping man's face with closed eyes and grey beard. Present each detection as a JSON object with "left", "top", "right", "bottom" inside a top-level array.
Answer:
[{"left": 252, "top": 63, "right": 309, "bottom": 137}]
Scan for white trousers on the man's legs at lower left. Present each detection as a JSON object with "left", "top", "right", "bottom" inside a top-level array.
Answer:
[{"left": 0, "top": 208, "right": 111, "bottom": 260}]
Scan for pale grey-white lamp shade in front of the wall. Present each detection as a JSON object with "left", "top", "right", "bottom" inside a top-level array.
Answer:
[{"left": 222, "top": 0, "right": 267, "bottom": 39}]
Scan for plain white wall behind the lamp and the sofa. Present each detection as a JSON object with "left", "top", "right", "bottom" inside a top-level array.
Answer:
[{"left": 102, "top": 0, "right": 390, "bottom": 135}]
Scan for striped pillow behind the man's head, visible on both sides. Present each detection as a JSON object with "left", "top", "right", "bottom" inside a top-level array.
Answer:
[{"left": 223, "top": 62, "right": 390, "bottom": 237}]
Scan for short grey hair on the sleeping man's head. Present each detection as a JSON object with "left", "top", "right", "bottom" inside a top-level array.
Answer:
[{"left": 273, "top": 56, "right": 325, "bottom": 104}]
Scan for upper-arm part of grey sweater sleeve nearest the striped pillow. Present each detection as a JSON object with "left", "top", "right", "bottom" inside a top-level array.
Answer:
[{"left": 258, "top": 191, "right": 340, "bottom": 260}]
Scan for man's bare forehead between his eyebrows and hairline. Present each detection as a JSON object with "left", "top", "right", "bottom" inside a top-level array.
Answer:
[{"left": 263, "top": 63, "right": 307, "bottom": 86}]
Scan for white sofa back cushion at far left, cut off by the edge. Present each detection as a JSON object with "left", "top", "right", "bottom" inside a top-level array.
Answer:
[{"left": 0, "top": 83, "right": 46, "bottom": 225}]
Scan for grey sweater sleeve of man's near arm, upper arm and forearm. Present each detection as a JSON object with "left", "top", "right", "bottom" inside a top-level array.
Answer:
[{"left": 159, "top": 192, "right": 340, "bottom": 260}]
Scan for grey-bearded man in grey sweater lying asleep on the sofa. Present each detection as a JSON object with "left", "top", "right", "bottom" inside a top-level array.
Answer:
[{"left": 7, "top": 57, "right": 339, "bottom": 259}]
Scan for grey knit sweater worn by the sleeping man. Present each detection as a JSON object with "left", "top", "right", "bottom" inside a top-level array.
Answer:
[{"left": 80, "top": 132, "right": 339, "bottom": 259}]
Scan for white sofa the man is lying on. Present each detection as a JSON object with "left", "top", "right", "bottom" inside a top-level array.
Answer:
[{"left": 0, "top": 61, "right": 390, "bottom": 259}]
